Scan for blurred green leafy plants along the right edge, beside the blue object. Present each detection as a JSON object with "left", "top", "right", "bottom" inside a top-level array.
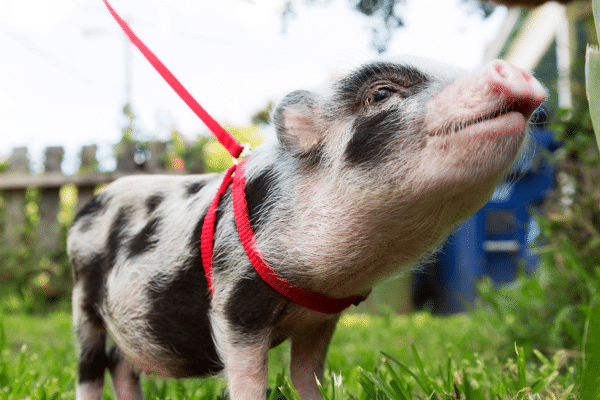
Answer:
[{"left": 475, "top": 31, "right": 600, "bottom": 399}]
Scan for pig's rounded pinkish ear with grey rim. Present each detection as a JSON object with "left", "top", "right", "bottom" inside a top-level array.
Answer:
[{"left": 273, "top": 90, "right": 323, "bottom": 157}]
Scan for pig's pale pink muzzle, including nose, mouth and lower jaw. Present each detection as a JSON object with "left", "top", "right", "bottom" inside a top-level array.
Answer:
[{"left": 415, "top": 60, "right": 546, "bottom": 202}]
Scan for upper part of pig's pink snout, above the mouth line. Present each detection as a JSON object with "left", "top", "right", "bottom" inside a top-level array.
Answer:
[{"left": 426, "top": 60, "right": 546, "bottom": 135}]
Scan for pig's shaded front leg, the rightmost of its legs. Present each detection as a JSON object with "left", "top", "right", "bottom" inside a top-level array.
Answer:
[{"left": 290, "top": 315, "right": 339, "bottom": 400}]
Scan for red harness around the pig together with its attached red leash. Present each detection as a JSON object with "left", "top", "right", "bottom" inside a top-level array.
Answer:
[{"left": 103, "top": 0, "right": 369, "bottom": 314}]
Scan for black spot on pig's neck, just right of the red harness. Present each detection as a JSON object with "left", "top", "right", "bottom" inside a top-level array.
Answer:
[{"left": 246, "top": 168, "right": 278, "bottom": 234}]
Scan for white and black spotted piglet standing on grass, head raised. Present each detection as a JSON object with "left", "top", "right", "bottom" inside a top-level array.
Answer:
[{"left": 68, "top": 60, "right": 546, "bottom": 400}]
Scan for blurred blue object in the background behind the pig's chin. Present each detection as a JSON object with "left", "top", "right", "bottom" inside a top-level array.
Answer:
[{"left": 413, "top": 129, "right": 558, "bottom": 313}]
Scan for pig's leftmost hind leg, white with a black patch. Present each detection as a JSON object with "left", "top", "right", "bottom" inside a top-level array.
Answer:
[{"left": 73, "top": 284, "right": 108, "bottom": 400}]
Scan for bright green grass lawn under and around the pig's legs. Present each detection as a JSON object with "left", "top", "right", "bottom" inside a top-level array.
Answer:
[{"left": 0, "top": 311, "right": 580, "bottom": 400}]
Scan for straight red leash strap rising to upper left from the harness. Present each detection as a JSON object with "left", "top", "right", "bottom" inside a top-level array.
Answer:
[{"left": 103, "top": 0, "right": 244, "bottom": 158}]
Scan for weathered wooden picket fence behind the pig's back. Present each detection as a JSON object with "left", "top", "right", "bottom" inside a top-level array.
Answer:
[{"left": 0, "top": 142, "right": 180, "bottom": 254}]
